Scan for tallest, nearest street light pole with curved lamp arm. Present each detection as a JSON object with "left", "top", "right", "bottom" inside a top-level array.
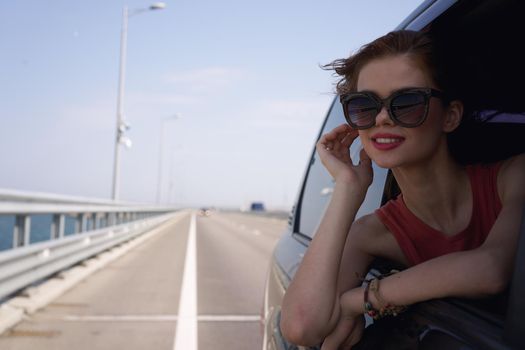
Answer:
[{"left": 112, "top": 2, "right": 166, "bottom": 200}]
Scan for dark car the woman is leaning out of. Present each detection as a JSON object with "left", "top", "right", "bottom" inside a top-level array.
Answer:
[{"left": 262, "top": 0, "right": 525, "bottom": 350}]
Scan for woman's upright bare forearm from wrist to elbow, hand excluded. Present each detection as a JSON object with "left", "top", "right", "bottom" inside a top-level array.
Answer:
[{"left": 281, "top": 184, "right": 371, "bottom": 346}]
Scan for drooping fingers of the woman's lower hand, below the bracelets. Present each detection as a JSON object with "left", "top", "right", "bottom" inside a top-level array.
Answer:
[{"left": 321, "top": 314, "right": 365, "bottom": 350}]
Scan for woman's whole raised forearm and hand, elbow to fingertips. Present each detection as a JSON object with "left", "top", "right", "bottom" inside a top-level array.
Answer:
[{"left": 281, "top": 125, "right": 372, "bottom": 345}]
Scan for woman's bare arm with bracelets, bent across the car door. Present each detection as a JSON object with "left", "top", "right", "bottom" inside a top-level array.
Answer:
[{"left": 341, "top": 155, "right": 525, "bottom": 315}]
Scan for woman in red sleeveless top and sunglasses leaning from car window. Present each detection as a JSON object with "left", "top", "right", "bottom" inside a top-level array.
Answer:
[{"left": 281, "top": 31, "right": 525, "bottom": 349}]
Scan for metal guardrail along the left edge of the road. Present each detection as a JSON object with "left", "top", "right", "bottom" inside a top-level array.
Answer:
[{"left": 0, "top": 189, "right": 175, "bottom": 299}]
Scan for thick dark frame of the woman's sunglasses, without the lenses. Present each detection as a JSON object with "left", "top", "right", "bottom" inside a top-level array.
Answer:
[{"left": 339, "top": 88, "right": 444, "bottom": 130}]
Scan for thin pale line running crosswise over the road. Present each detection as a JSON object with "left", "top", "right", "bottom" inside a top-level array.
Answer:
[{"left": 60, "top": 315, "right": 261, "bottom": 322}]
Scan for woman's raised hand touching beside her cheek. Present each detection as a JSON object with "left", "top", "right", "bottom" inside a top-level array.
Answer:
[{"left": 316, "top": 124, "right": 373, "bottom": 192}]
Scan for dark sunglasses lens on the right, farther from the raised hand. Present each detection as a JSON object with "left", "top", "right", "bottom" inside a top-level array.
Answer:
[{"left": 390, "top": 92, "right": 426, "bottom": 126}]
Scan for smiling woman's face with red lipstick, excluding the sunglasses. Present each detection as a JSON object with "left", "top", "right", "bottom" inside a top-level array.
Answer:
[{"left": 357, "top": 55, "right": 446, "bottom": 168}]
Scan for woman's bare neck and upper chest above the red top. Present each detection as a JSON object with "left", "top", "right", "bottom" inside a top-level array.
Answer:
[{"left": 392, "top": 146, "right": 472, "bottom": 234}]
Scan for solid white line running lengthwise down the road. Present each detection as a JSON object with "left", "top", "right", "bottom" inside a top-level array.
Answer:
[{"left": 173, "top": 213, "right": 198, "bottom": 350}]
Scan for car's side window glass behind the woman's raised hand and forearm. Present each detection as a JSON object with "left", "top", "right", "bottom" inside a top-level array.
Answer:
[{"left": 299, "top": 99, "right": 387, "bottom": 237}]
